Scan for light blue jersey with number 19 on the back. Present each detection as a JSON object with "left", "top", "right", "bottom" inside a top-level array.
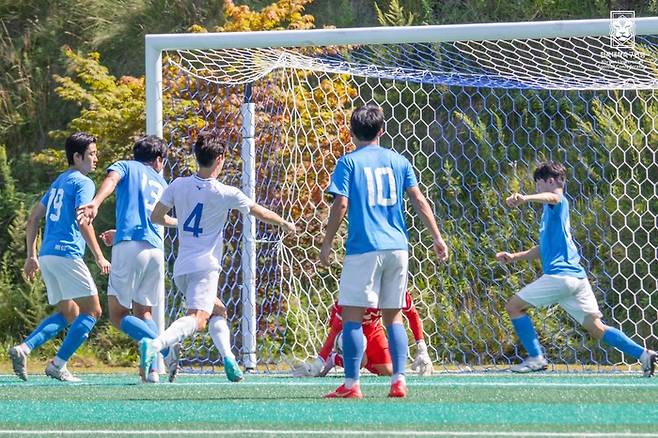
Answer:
[{"left": 39, "top": 169, "right": 96, "bottom": 259}]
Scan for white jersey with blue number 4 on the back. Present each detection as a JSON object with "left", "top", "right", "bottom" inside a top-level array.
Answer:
[{"left": 160, "top": 175, "right": 254, "bottom": 277}]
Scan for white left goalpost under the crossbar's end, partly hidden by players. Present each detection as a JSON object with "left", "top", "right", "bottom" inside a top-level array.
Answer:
[{"left": 144, "top": 39, "right": 167, "bottom": 372}]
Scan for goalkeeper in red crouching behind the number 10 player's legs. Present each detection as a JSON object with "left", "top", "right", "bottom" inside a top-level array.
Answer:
[{"left": 293, "top": 292, "right": 434, "bottom": 377}]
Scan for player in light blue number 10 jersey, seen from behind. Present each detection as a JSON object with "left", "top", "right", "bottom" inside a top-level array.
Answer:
[{"left": 320, "top": 105, "right": 448, "bottom": 398}]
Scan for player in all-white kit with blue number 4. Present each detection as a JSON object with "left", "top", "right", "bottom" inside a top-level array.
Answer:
[{"left": 140, "top": 132, "right": 296, "bottom": 382}]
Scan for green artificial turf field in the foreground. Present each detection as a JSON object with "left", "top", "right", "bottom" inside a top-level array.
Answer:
[{"left": 0, "top": 373, "right": 658, "bottom": 437}]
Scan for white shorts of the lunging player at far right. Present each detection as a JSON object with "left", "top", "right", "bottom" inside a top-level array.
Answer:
[{"left": 516, "top": 275, "right": 603, "bottom": 324}]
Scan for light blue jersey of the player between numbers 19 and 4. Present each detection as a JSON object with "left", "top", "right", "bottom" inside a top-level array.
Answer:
[{"left": 107, "top": 161, "right": 167, "bottom": 248}]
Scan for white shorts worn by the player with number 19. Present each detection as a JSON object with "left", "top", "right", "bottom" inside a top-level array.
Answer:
[{"left": 39, "top": 256, "right": 98, "bottom": 306}]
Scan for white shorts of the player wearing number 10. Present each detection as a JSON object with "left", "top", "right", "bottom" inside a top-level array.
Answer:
[{"left": 338, "top": 250, "right": 409, "bottom": 309}]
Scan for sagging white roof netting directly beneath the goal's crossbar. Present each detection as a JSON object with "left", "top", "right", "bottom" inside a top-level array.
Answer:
[{"left": 171, "top": 37, "right": 658, "bottom": 90}]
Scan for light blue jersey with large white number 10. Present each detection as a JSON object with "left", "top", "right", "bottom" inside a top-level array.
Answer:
[{"left": 327, "top": 145, "right": 418, "bottom": 255}]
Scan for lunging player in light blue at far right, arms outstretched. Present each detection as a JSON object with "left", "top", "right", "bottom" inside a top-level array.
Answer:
[{"left": 496, "top": 161, "right": 658, "bottom": 377}]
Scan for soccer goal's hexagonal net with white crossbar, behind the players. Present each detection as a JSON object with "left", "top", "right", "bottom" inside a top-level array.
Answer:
[{"left": 147, "top": 19, "right": 658, "bottom": 371}]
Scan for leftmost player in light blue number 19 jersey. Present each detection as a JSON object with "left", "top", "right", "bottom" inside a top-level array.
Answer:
[{"left": 9, "top": 132, "right": 110, "bottom": 382}]
